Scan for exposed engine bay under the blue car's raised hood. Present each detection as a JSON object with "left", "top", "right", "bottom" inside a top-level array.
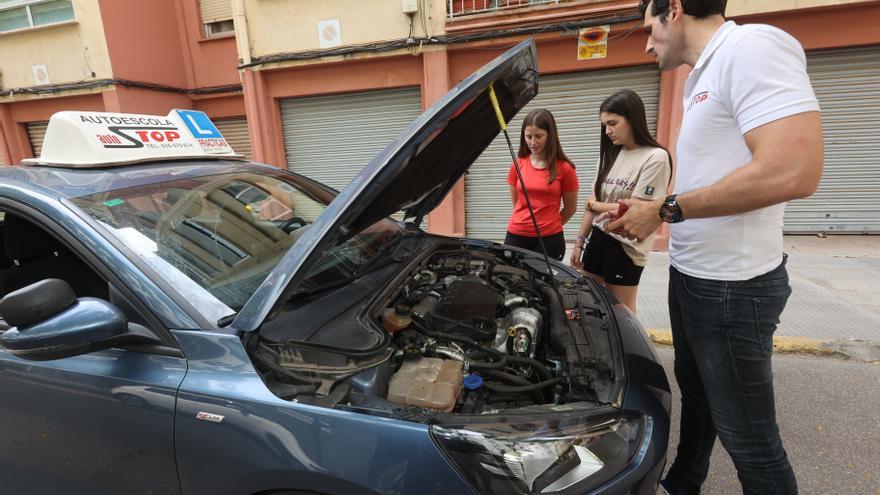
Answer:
[{"left": 251, "top": 245, "right": 621, "bottom": 422}]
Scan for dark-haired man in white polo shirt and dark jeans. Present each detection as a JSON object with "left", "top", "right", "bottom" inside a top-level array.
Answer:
[{"left": 606, "top": 0, "right": 823, "bottom": 494}]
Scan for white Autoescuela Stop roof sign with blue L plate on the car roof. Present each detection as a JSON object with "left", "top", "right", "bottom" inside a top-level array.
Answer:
[{"left": 22, "top": 110, "right": 243, "bottom": 168}]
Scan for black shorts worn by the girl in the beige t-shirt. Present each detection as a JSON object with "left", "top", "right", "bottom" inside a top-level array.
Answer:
[{"left": 581, "top": 227, "right": 644, "bottom": 286}]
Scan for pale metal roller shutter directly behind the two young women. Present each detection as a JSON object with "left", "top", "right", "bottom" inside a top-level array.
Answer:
[{"left": 465, "top": 65, "right": 660, "bottom": 241}]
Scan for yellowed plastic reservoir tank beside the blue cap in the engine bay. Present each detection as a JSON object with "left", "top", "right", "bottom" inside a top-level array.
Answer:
[{"left": 388, "top": 358, "right": 462, "bottom": 412}]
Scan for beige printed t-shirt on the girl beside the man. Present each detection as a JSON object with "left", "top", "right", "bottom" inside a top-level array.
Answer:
[{"left": 590, "top": 146, "right": 672, "bottom": 266}]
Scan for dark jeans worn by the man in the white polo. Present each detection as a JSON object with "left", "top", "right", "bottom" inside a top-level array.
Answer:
[{"left": 664, "top": 257, "right": 797, "bottom": 495}]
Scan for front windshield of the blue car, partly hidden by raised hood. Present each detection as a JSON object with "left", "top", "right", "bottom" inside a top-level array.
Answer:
[{"left": 72, "top": 169, "right": 401, "bottom": 321}]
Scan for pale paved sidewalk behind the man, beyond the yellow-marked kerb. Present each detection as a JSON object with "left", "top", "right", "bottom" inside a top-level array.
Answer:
[{"left": 565, "top": 235, "right": 880, "bottom": 343}]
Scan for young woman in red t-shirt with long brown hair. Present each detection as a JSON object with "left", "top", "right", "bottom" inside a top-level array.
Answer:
[{"left": 504, "top": 108, "right": 578, "bottom": 260}]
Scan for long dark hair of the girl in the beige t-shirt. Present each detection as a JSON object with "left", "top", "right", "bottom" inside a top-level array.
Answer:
[{"left": 593, "top": 89, "right": 672, "bottom": 199}]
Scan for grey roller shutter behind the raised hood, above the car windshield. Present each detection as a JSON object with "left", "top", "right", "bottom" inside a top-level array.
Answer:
[{"left": 281, "top": 88, "right": 422, "bottom": 190}]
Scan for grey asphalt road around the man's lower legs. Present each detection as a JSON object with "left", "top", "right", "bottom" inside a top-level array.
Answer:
[{"left": 657, "top": 346, "right": 880, "bottom": 495}]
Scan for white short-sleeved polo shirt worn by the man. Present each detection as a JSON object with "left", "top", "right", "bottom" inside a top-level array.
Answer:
[{"left": 669, "top": 21, "right": 819, "bottom": 280}]
